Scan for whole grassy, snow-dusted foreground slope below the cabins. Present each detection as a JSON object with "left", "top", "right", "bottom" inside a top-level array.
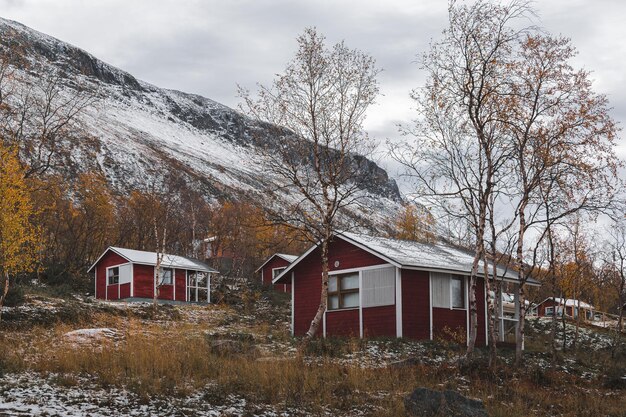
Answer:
[{"left": 0, "top": 290, "right": 626, "bottom": 417}]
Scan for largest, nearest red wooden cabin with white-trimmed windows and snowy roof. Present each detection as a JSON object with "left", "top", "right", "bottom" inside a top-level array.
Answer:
[{"left": 273, "top": 233, "right": 538, "bottom": 345}]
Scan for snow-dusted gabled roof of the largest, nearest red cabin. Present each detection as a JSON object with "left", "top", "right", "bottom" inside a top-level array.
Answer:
[{"left": 274, "top": 232, "right": 540, "bottom": 285}]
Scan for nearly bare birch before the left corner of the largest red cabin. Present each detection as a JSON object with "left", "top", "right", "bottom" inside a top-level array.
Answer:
[{"left": 240, "top": 28, "right": 379, "bottom": 338}]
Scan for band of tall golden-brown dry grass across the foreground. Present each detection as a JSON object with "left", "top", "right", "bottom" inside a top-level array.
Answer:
[{"left": 0, "top": 302, "right": 626, "bottom": 417}]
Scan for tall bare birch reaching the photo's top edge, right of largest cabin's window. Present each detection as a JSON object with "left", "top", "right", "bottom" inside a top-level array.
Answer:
[{"left": 392, "top": 1, "right": 530, "bottom": 357}]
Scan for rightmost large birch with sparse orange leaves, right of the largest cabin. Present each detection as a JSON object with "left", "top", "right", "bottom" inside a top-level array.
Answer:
[{"left": 507, "top": 34, "right": 618, "bottom": 364}]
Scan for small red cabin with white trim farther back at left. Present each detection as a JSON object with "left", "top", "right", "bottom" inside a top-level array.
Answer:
[{"left": 88, "top": 247, "right": 218, "bottom": 303}]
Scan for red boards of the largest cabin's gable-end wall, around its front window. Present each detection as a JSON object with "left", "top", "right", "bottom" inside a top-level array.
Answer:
[{"left": 293, "top": 239, "right": 386, "bottom": 336}]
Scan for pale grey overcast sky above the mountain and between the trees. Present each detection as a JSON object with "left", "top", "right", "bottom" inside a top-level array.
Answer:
[{"left": 0, "top": 0, "right": 626, "bottom": 179}]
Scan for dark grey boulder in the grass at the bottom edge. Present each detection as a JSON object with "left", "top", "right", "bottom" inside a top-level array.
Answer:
[{"left": 404, "top": 388, "right": 489, "bottom": 417}]
